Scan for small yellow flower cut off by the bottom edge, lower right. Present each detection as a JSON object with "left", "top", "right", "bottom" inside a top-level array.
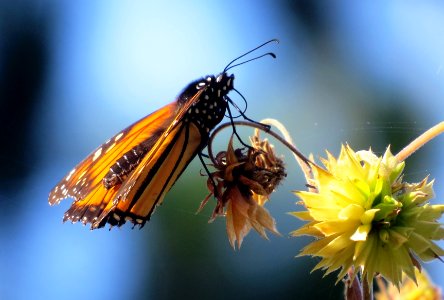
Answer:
[{"left": 375, "top": 269, "right": 442, "bottom": 300}]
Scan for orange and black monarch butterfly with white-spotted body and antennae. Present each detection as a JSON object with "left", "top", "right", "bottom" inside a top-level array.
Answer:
[{"left": 48, "top": 40, "right": 278, "bottom": 229}]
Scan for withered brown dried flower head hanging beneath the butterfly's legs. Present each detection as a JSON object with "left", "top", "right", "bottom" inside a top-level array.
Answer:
[{"left": 200, "top": 134, "right": 286, "bottom": 248}]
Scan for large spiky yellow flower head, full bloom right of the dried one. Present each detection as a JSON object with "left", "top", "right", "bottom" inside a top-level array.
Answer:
[{"left": 292, "top": 145, "right": 444, "bottom": 286}]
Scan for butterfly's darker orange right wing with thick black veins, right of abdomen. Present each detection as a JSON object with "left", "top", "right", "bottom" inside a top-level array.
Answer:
[{"left": 97, "top": 119, "right": 201, "bottom": 227}]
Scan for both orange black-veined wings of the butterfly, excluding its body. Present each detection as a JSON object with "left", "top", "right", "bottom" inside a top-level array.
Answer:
[{"left": 49, "top": 91, "right": 207, "bottom": 229}]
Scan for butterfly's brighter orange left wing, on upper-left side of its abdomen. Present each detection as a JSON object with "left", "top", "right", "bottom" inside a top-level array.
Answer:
[{"left": 49, "top": 102, "right": 179, "bottom": 223}]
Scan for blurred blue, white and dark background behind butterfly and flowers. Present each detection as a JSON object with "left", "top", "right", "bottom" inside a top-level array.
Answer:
[{"left": 0, "top": 0, "right": 444, "bottom": 299}]
